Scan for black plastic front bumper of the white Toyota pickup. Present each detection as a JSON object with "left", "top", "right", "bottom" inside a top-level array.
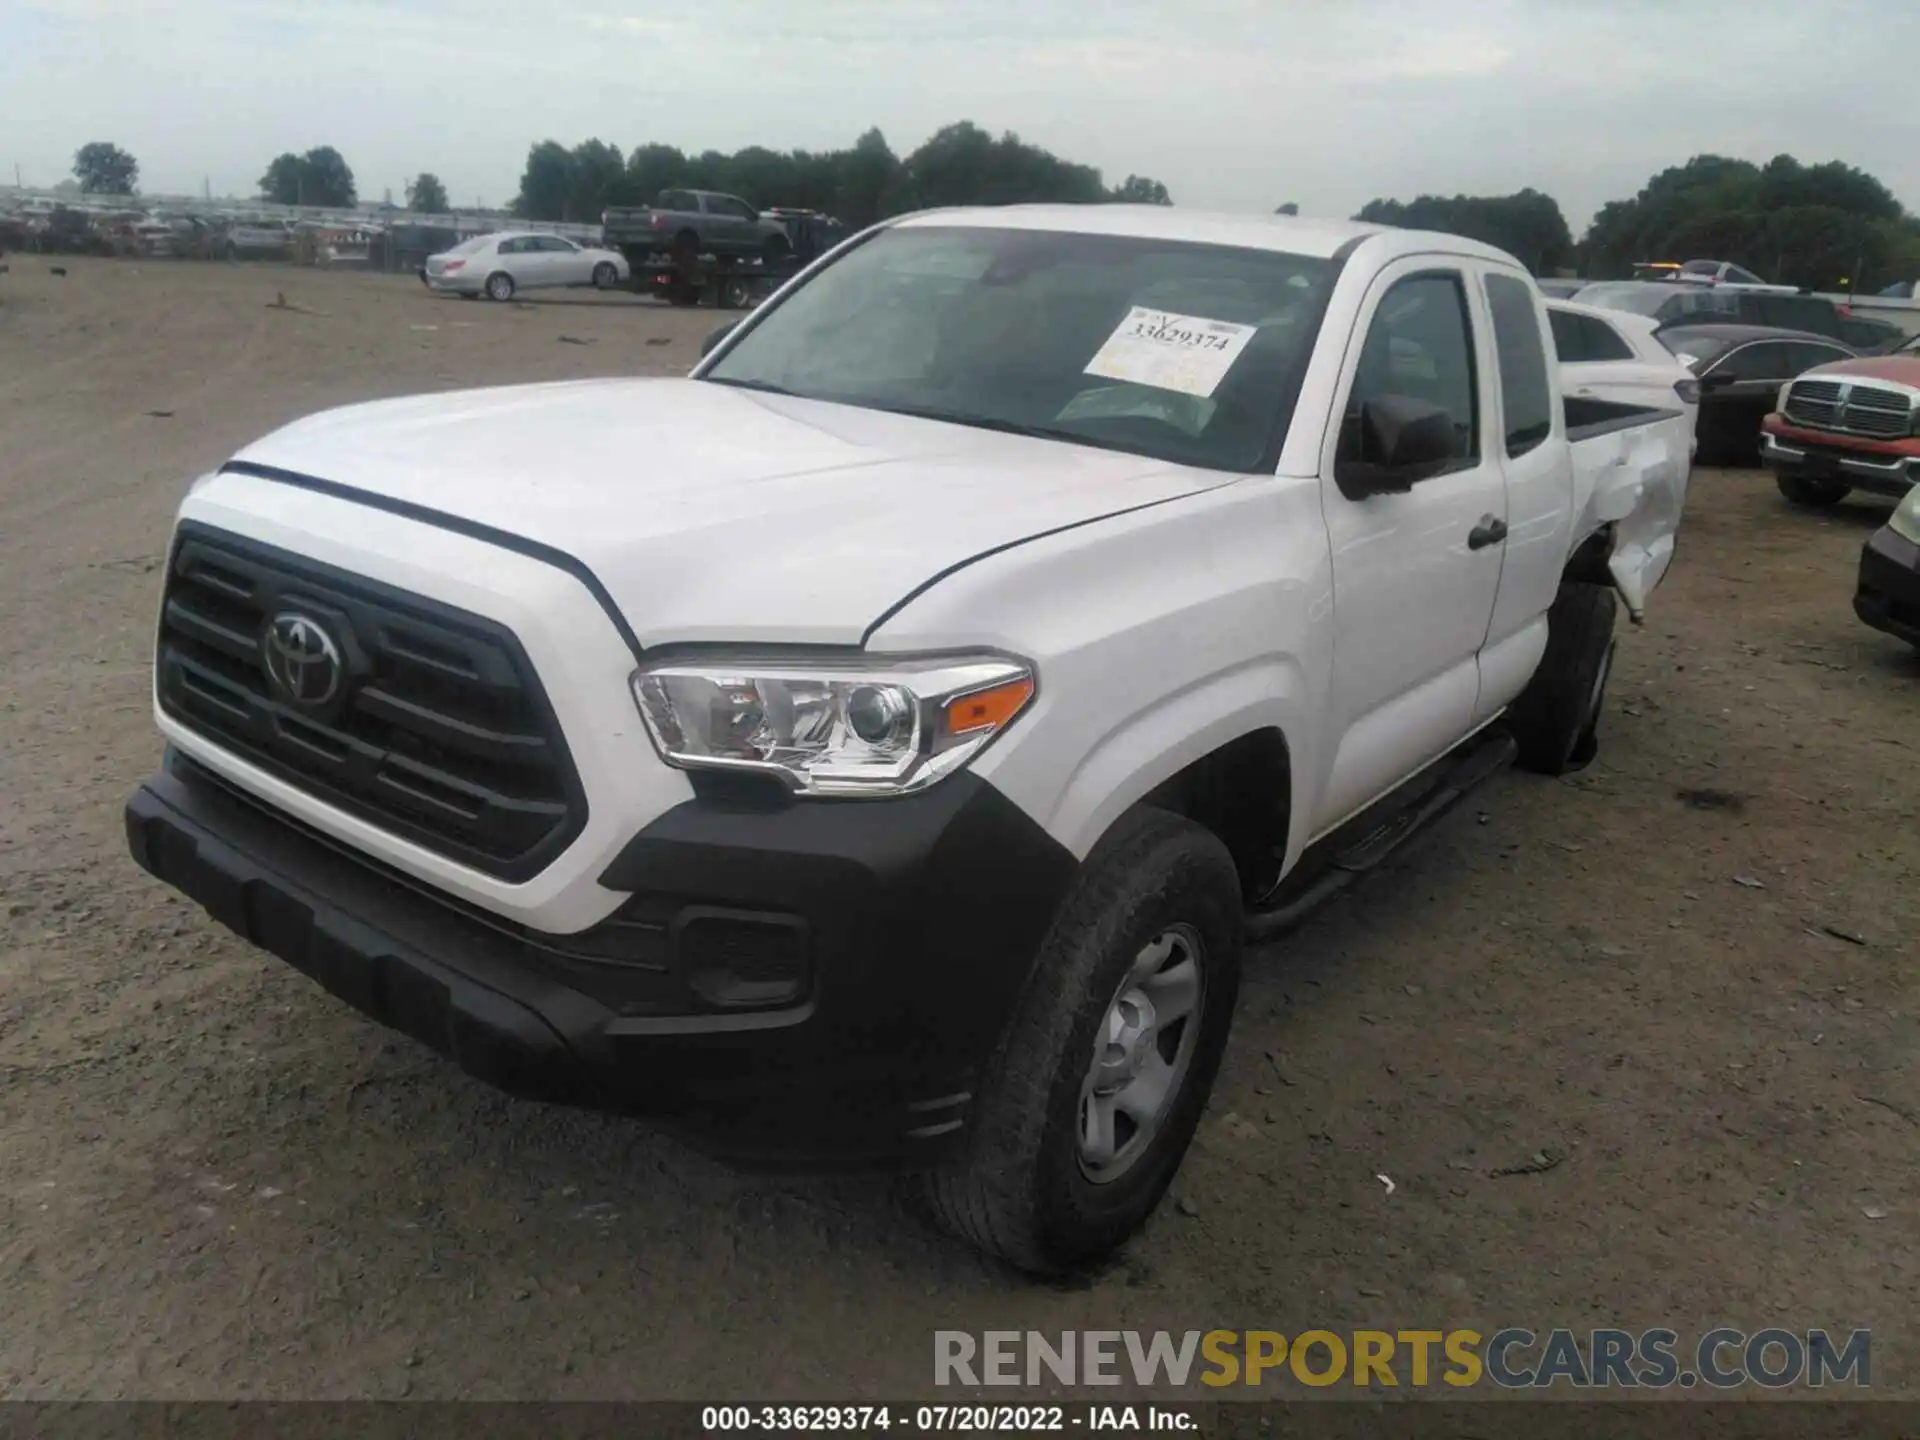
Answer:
[{"left": 127, "top": 753, "right": 1075, "bottom": 1165}]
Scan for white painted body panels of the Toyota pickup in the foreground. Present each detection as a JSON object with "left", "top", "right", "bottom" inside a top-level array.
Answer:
[{"left": 161, "top": 207, "right": 1690, "bottom": 925}]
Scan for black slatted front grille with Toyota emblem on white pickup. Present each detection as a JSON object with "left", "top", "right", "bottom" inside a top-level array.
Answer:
[{"left": 156, "top": 526, "right": 586, "bottom": 879}]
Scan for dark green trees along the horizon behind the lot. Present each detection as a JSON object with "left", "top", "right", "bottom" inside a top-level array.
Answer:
[{"left": 60, "top": 134, "right": 1920, "bottom": 290}]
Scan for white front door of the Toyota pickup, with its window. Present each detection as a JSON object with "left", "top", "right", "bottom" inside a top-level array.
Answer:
[{"left": 1313, "top": 257, "right": 1507, "bottom": 835}]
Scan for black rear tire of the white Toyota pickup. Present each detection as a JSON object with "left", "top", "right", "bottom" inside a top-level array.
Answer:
[{"left": 1507, "top": 584, "right": 1615, "bottom": 776}]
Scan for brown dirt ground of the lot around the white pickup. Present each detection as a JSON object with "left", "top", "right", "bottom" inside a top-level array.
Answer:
[{"left": 0, "top": 257, "right": 1920, "bottom": 1400}]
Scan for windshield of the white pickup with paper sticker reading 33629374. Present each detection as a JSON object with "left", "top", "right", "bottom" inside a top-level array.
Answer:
[{"left": 703, "top": 227, "right": 1332, "bottom": 470}]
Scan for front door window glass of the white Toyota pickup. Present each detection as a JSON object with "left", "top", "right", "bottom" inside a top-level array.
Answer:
[{"left": 1340, "top": 271, "right": 1474, "bottom": 468}]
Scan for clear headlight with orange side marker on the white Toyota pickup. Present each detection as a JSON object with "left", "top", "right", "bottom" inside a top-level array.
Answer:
[{"left": 632, "top": 655, "right": 1035, "bottom": 795}]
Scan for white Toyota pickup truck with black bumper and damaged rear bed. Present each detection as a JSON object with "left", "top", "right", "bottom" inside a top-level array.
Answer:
[{"left": 127, "top": 205, "right": 1692, "bottom": 1271}]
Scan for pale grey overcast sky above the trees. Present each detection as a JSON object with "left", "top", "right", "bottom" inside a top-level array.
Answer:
[{"left": 0, "top": 0, "right": 1920, "bottom": 234}]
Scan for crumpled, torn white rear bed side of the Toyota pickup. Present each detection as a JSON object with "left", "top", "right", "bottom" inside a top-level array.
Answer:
[{"left": 1572, "top": 415, "right": 1693, "bottom": 624}]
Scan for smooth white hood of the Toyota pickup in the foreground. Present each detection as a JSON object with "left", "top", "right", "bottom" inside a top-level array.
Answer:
[{"left": 234, "top": 380, "right": 1235, "bottom": 645}]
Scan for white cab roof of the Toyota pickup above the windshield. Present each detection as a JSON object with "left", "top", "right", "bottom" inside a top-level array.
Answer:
[{"left": 895, "top": 205, "right": 1515, "bottom": 265}]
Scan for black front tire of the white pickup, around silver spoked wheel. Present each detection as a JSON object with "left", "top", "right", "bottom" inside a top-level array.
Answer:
[{"left": 927, "top": 806, "right": 1240, "bottom": 1275}]
